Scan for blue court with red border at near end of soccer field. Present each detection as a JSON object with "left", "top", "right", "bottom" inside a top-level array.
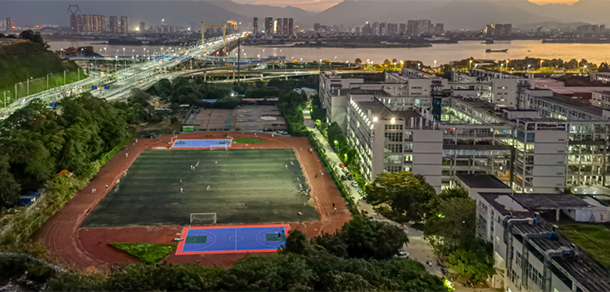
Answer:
[{"left": 176, "top": 224, "right": 290, "bottom": 255}]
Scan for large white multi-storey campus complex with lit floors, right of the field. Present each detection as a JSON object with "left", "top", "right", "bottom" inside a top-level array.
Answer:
[{"left": 319, "top": 69, "right": 610, "bottom": 193}]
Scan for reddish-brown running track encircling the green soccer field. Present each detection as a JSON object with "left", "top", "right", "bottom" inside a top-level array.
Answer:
[{"left": 34, "top": 132, "right": 351, "bottom": 270}]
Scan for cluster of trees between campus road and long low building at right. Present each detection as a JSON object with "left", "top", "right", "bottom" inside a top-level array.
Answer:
[{"left": 366, "top": 171, "right": 495, "bottom": 281}]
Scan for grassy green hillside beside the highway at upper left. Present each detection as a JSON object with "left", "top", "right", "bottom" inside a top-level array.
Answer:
[{"left": 0, "top": 40, "right": 85, "bottom": 104}]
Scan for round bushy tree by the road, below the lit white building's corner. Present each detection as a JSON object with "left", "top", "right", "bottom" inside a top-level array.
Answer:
[{"left": 366, "top": 171, "right": 436, "bottom": 222}]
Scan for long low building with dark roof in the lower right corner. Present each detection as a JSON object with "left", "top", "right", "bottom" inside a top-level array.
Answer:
[{"left": 468, "top": 187, "right": 610, "bottom": 292}]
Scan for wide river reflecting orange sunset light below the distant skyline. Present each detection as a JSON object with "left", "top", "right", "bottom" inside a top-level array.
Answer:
[{"left": 49, "top": 40, "right": 610, "bottom": 65}]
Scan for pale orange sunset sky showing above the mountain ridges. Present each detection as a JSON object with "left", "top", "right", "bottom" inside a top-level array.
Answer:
[{"left": 230, "top": 0, "right": 579, "bottom": 12}]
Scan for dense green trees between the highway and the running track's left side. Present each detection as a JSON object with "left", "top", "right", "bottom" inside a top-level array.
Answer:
[{"left": 0, "top": 94, "right": 139, "bottom": 207}]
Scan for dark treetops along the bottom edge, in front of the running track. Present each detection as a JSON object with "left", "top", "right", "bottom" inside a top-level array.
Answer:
[{"left": 8, "top": 218, "right": 448, "bottom": 291}]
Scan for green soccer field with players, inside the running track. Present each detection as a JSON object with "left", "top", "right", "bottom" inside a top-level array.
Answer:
[{"left": 83, "top": 149, "right": 319, "bottom": 227}]
